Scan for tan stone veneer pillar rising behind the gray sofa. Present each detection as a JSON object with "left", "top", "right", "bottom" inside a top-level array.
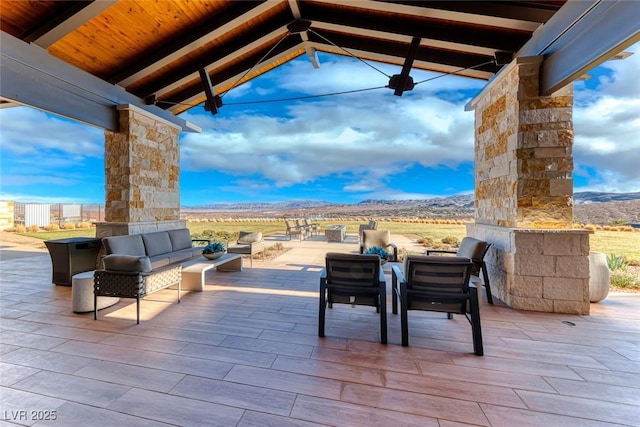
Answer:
[{"left": 96, "top": 105, "right": 186, "bottom": 237}]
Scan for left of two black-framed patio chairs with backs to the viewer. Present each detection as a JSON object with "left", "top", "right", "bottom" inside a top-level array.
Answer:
[{"left": 318, "top": 252, "right": 387, "bottom": 344}]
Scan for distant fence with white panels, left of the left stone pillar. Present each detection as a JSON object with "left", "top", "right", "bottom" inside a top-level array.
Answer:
[{"left": 13, "top": 202, "right": 105, "bottom": 227}]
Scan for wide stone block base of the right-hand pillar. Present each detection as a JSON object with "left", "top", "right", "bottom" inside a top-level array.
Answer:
[{"left": 467, "top": 223, "right": 591, "bottom": 314}]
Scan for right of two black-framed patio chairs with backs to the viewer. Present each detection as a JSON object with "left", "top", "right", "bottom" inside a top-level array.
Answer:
[{"left": 391, "top": 255, "right": 484, "bottom": 356}]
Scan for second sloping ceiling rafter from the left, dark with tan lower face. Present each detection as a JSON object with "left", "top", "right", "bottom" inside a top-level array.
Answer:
[{"left": 113, "top": 0, "right": 278, "bottom": 87}]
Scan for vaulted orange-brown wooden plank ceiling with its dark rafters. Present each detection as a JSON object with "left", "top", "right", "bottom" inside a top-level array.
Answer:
[{"left": 0, "top": 0, "right": 566, "bottom": 114}]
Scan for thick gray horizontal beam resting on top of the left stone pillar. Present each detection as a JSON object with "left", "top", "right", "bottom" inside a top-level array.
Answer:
[{"left": 0, "top": 32, "right": 201, "bottom": 132}]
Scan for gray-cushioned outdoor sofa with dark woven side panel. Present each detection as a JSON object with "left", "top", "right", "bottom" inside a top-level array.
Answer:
[{"left": 94, "top": 228, "right": 208, "bottom": 323}]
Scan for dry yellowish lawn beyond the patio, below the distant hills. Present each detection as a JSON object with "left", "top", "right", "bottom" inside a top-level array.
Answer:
[{"left": 15, "top": 220, "right": 640, "bottom": 264}]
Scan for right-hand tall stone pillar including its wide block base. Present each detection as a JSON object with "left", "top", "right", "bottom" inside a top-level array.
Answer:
[{"left": 467, "top": 57, "right": 589, "bottom": 314}]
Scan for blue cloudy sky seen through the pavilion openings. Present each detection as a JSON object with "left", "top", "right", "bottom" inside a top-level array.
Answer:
[{"left": 0, "top": 44, "right": 640, "bottom": 206}]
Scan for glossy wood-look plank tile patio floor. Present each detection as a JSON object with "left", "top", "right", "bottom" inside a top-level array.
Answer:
[{"left": 0, "top": 232, "right": 640, "bottom": 427}]
